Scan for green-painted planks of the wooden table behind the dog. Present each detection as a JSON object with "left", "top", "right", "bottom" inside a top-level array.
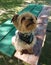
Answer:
[{"left": 0, "top": 4, "right": 42, "bottom": 57}]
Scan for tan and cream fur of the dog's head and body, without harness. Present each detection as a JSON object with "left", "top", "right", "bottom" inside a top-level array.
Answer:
[{"left": 12, "top": 12, "right": 36, "bottom": 53}]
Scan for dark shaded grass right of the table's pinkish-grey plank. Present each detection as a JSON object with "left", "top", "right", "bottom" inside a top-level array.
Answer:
[{"left": 39, "top": 22, "right": 51, "bottom": 65}]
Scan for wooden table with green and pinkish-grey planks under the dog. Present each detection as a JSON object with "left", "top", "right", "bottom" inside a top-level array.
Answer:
[{"left": 0, "top": 4, "right": 51, "bottom": 65}]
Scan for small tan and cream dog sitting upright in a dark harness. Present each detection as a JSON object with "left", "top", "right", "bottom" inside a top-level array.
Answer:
[{"left": 12, "top": 12, "right": 37, "bottom": 54}]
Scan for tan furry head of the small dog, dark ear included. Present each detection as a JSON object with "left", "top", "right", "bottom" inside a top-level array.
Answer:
[{"left": 12, "top": 12, "right": 36, "bottom": 33}]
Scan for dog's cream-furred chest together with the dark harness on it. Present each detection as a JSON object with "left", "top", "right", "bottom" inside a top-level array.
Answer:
[{"left": 16, "top": 30, "right": 36, "bottom": 49}]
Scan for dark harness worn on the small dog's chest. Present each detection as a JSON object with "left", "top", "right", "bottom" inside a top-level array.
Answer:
[{"left": 18, "top": 32, "right": 33, "bottom": 44}]
